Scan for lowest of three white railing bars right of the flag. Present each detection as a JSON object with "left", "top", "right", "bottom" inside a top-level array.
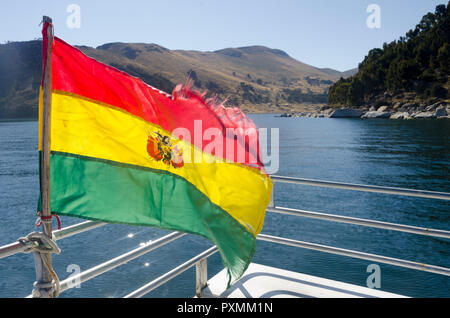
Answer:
[{"left": 256, "top": 234, "right": 450, "bottom": 276}]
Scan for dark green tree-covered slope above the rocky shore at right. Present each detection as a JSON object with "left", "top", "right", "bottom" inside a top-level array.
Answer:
[{"left": 328, "top": 2, "right": 450, "bottom": 107}]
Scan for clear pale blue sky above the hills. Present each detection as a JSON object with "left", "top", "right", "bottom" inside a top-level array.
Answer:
[{"left": 0, "top": 0, "right": 447, "bottom": 71}]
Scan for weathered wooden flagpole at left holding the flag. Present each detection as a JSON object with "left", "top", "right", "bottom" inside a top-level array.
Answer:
[{"left": 35, "top": 16, "right": 56, "bottom": 297}]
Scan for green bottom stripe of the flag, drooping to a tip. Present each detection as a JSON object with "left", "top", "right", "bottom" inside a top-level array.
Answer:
[{"left": 50, "top": 152, "right": 255, "bottom": 278}]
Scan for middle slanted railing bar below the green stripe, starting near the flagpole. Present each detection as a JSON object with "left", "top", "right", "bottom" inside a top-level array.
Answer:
[{"left": 53, "top": 232, "right": 186, "bottom": 292}]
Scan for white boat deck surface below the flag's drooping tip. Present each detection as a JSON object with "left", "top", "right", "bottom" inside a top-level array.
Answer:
[{"left": 202, "top": 263, "right": 405, "bottom": 298}]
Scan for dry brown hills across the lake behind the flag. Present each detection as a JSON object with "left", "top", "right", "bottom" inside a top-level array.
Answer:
[{"left": 0, "top": 41, "right": 354, "bottom": 119}]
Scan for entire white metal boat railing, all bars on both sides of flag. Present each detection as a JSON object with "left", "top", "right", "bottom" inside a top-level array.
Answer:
[{"left": 0, "top": 176, "right": 450, "bottom": 298}]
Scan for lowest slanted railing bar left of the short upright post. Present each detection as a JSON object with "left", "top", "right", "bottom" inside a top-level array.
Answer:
[{"left": 124, "top": 246, "right": 217, "bottom": 298}]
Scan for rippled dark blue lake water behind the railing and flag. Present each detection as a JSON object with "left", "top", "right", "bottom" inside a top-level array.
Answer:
[{"left": 0, "top": 115, "right": 450, "bottom": 297}]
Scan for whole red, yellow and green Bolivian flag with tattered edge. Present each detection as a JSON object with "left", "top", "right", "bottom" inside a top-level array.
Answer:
[{"left": 39, "top": 23, "right": 272, "bottom": 279}]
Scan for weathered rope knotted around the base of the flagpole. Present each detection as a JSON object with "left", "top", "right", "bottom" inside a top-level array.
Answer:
[{"left": 17, "top": 232, "right": 61, "bottom": 298}]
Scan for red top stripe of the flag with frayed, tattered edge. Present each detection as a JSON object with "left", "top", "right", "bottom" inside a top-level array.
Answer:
[{"left": 50, "top": 34, "right": 264, "bottom": 170}]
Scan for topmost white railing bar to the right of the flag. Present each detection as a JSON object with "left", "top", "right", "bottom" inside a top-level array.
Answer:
[{"left": 270, "top": 176, "right": 450, "bottom": 200}]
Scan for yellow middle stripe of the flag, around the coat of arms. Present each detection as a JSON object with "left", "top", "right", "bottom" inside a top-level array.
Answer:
[{"left": 51, "top": 92, "right": 271, "bottom": 235}]
